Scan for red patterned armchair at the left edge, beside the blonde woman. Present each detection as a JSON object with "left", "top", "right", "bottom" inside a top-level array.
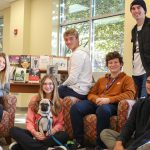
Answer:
[{"left": 0, "top": 95, "right": 17, "bottom": 144}]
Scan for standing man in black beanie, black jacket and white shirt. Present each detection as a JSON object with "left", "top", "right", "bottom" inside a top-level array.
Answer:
[{"left": 130, "top": 0, "right": 150, "bottom": 98}]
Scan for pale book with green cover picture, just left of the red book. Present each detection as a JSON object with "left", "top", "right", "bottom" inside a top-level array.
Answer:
[{"left": 14, "top": 67, "right": 26, "bottom": 82}]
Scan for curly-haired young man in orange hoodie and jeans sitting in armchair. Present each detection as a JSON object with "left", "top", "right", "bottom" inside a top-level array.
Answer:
[{"left": 70, "top": 51, "right": 135, "bottom": 150}]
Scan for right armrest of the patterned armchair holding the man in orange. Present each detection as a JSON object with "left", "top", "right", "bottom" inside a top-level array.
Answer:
[{"left": 117, "top": 100, "right": 136, "bottom": 132}]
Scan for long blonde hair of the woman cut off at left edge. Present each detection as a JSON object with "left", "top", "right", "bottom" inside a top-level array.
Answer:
[{"left": 0, "top": 52, "right": 9, "bottom": 86}]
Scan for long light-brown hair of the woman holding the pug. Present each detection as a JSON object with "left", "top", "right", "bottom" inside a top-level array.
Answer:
[{"left": 29, "top": 75, "right": 62, "bottom": 116}]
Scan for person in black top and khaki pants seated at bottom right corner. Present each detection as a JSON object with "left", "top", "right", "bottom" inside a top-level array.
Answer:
[{"left": 100, "top": 74, "right": 150, "bottom": 150}]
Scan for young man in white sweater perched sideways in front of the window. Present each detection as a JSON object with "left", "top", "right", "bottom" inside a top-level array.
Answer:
[{"left": 58, "top": 29, "right": 92, "bottom": 100}]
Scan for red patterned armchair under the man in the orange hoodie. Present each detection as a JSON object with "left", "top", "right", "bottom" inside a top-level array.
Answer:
[{"left": 63, "top": 97, "right": 135, "bottom": 144}]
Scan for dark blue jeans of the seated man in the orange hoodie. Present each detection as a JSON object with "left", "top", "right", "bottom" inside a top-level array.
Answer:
[{"left": 70, "top": 100, "right": 117, "bottom": 148}]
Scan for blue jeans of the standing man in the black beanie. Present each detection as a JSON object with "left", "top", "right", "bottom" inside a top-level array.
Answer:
[{"left": 132, "top": 73, "right": 147, "bottom": 98}]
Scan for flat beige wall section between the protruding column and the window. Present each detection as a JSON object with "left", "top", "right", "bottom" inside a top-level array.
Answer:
[{"left": 30, "top": 0, "right": 52, "bottom": 55}]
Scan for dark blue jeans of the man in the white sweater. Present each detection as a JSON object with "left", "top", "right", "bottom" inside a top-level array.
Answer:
[{"left": 58, "top": 85, "right": 87, "bottom": 100}]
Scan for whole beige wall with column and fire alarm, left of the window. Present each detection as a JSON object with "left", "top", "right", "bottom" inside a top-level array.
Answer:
[{"left": 0, "top": 0, "right": 52, "bottom": 55}]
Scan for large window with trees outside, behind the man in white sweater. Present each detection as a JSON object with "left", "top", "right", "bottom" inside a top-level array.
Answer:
[{"left": 59, "top": 0, "right": 125, "bottom": 72}]
